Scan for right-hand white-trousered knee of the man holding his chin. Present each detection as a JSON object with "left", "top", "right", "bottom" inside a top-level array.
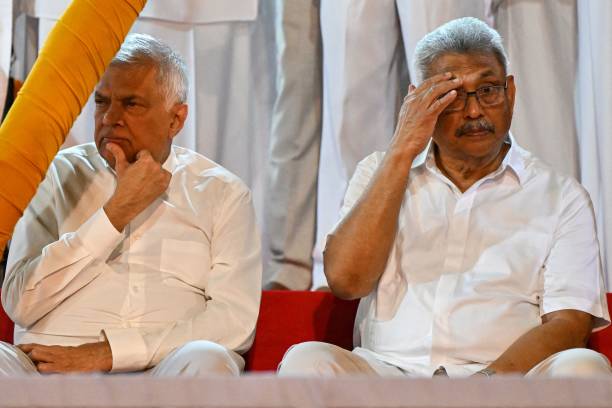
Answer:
[{"left": 155, "top": 340, "right": 244, "bottom": 377}]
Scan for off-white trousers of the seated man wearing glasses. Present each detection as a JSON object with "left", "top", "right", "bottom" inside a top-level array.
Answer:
[{"left": 278, "top": 341, "right": 612, "bottom": 378}]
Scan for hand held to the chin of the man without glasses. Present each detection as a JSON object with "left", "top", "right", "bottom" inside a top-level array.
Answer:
[{"left": 104, "top": 143, "right": 172, "bottom": 231}]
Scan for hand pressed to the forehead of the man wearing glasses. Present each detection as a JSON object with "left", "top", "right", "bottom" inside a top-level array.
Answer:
[{"left": 391, "top": 72, "right": 461, "bottom": 158}]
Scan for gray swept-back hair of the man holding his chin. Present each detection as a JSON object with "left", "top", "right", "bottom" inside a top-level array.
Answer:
[{"left": 110, "top": 34, "right": 189, "bottom": 104}]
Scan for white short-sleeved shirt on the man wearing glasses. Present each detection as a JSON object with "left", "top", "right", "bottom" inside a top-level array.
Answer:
[{"left": 341, "top": 138, "right": 610, "bottom": 375}]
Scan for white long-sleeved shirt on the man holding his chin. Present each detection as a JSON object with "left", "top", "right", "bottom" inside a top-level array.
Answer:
[{"left": 2, "top": 144, "right": 261, "bottom": 371}]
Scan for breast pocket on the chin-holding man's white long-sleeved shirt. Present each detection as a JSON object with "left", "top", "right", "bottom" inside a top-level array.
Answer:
[{"left": 160, "top": 239, "right": 210, "bottom": 290}]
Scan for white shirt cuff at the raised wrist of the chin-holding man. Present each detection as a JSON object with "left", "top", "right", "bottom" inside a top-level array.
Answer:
[{"left": 77, "top": 208, "right": 123, "bottom": 262}]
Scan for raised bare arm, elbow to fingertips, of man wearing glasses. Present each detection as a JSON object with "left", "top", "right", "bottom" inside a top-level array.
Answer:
[{"left": 323, "top": 73, "right": 461, "bottom": 299}]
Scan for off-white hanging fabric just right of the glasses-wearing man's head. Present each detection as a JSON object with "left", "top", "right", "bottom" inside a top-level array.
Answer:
[{"left": 493, "top": 0, "right": 580, "bottom": 178}]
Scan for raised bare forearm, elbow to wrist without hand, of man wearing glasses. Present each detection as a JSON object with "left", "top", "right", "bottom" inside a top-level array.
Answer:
[{"left": 323, "top": 151, "right": 414, "bottom": 299}]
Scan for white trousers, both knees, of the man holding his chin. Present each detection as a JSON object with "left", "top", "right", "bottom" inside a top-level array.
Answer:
[{"left": 0, "top": 340, "right": 244, "bottom": 377}]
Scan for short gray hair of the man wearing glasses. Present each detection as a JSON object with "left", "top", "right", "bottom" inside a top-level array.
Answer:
[{"left": 414, "top": 17, "right": 508, "bottom": 81}]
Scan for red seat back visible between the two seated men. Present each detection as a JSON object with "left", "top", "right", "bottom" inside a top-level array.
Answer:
[{"left": 245, "top": 291, "right": 358, "bottom": 371}]
